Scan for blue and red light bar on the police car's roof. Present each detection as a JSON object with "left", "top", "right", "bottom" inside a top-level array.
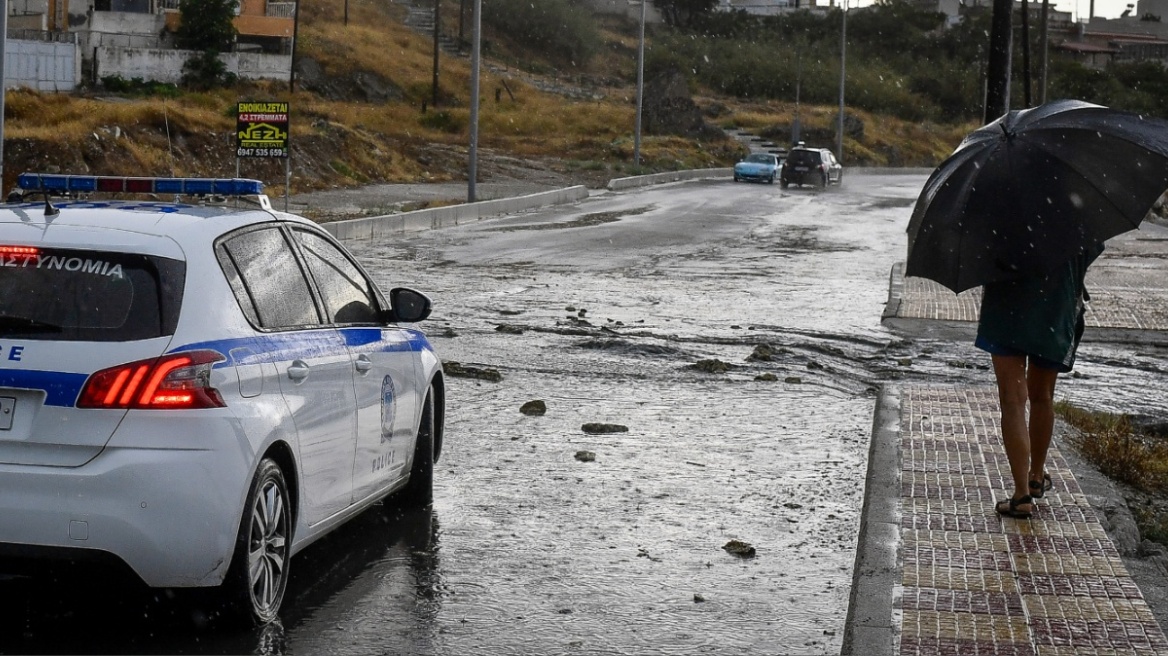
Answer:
[{"left": 16, "top": 173, "right": 264, "bottom": 196}]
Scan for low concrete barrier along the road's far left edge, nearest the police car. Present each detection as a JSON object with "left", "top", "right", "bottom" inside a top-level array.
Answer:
[{"left": 321, "top": 186, "right": 589, "bottom": 242}]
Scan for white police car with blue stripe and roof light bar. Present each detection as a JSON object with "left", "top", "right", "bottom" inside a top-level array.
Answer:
[{"left": 0, "top": 174, "right": 445, "bottom": 622}]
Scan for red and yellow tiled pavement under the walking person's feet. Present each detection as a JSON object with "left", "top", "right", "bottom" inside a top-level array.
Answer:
[{"left": 892, "top": 386, "right": 1168, "bottom": 656}]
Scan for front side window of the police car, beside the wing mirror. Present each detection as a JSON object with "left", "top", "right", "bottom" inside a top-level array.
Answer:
[{"left": 292, "top": 229, "right": 377, "bottom": 323}]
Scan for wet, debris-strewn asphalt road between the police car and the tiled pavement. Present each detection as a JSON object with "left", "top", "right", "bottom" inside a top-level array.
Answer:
[{"left": 0, "top": 175, "right": 1158, "bottom": 655}]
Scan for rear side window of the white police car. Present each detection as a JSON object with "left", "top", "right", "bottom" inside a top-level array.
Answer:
[{"left": 217, "top": 226, "right": 320, "bottom": 329}]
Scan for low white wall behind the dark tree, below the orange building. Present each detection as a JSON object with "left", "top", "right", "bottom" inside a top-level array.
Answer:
[{"left": 95, "top": 47, "right": 292, "bottom": 83}]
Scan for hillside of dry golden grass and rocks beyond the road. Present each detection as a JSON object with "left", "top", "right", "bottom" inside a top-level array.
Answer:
[{"left": 4, "top": 0, "right": 968, "bottom": 194}]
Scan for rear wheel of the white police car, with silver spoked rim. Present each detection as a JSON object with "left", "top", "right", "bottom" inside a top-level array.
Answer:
[{"left": 223, "top": 458, "right": 292, "bottom": 624}]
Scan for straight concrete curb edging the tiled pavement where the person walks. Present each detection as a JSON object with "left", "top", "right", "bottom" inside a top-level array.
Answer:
[{"left": 840, "top": 385, "right": 902, "bottom": 656}]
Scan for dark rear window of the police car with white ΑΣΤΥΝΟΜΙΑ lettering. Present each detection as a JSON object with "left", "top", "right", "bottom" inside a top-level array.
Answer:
[{"left": 0, "top": 246, "right": 186, "bottom": 342}]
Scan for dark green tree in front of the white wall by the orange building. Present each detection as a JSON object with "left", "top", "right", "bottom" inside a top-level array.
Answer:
[{"left": 175, "top": 0, "right": 237, "bottom": 89}]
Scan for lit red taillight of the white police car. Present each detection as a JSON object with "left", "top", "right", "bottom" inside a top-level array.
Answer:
[{"left": 77, "top": 350, "right": 227, "bottom": 410}]
